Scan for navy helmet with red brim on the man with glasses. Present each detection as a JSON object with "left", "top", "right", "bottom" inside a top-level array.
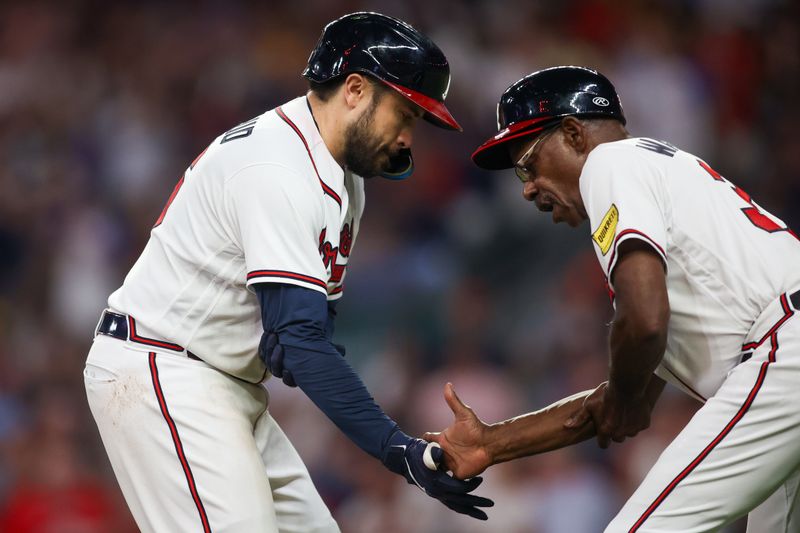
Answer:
[{"left": 472, "top": 67, "right": 625, "bottom": 170}]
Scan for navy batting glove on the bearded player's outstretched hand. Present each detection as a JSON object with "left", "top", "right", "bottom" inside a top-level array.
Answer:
[{"left": 383, "top": 430, "right": 494, "bottom": 520}]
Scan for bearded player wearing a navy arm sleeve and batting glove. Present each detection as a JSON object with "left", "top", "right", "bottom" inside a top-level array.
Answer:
[{"left": 84, "top": 13, "right": 492, "bottom": 533}]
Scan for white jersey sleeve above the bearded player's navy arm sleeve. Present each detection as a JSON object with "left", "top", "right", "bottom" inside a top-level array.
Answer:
[{"left": 226, "top": 163, "right": 327, "bottom": 294}]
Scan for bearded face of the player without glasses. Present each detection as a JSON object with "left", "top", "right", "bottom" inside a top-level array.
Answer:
[{"left": 344, "top": 89, "right": 423, "bottom": 178}]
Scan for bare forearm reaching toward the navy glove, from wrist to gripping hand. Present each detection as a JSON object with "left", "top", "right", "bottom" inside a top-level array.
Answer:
[{"left": 478, "top": 390, "right": 595, "bottom": 464}]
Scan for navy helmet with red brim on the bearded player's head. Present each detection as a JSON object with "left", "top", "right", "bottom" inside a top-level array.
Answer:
[{"left": 303, "top": 12, "right": 461, "bottom": 131}]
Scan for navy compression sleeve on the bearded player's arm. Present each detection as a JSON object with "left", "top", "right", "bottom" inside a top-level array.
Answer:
[{"left": 255, "top": 283, "right": 398, "bottom": 459}]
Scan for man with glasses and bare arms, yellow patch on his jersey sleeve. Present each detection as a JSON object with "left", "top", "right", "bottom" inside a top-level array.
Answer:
[{"left": 426, "top": 67, "right": 800, "bottom": 533}]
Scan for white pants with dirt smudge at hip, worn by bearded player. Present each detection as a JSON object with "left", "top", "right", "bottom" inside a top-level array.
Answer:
[{"left": 84, "top": 335, "right": 339, "bottom": 533}]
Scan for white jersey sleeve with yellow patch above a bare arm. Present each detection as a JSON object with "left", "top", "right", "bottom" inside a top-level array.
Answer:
[{"left": 580, "top": 141, "right": 668, "bottom": 285}]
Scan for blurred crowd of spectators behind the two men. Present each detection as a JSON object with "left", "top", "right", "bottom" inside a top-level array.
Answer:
[{"left": 0, "top": 0, "right": 800, "bottom": 533}]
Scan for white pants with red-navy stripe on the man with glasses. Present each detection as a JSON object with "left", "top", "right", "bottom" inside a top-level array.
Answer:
[{"left": 606, "top": 295, "right": 800, "bottom": 533}]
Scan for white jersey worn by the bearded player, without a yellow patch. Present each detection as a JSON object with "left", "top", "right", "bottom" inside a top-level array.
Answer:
[{"left": 108, "top": 97, "right": 364, "bottom": 382}]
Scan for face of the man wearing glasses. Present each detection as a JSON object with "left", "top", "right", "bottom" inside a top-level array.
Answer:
[{"left": 509, "top": 127, "right": 588, "bottom": 227}]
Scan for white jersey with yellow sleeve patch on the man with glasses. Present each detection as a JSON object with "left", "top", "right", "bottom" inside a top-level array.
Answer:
[{"left": 580, "top": 138, "right": 800, "bottom": 400}]
